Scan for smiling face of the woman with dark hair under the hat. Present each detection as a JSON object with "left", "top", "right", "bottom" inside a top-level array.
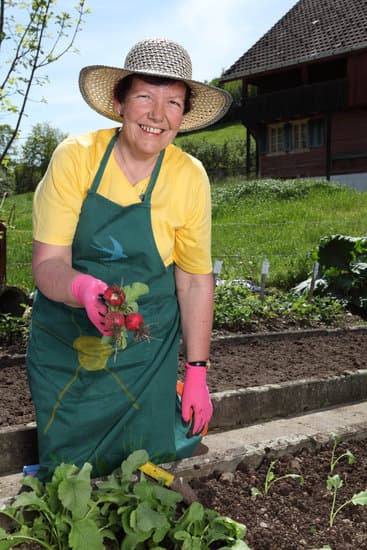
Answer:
[{"left": 115, "top": 77, "right": 186, "bottom": 156}]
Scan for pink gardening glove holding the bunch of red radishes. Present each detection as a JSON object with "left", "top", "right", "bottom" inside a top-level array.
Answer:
[{"left": 71, "top": 273, "right": 112, "bottom": 336}]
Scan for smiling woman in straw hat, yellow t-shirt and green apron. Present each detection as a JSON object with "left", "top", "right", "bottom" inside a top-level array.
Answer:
[{"left": 27, "top": 39, "right": 231, "bottom": 478}]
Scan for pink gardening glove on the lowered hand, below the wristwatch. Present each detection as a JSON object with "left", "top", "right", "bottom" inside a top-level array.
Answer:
[{"left": 181, "top": 363, "right": 213, "bottom": 434}]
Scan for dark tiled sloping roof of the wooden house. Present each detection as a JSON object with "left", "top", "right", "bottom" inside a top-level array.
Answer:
[{"left": 221, "top": 0, "right": 367, "bottom": 81}]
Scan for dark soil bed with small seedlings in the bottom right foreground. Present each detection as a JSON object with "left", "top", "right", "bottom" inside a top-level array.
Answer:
[{"left": 191, "top": 441, "right": 367, "bottom": 550}]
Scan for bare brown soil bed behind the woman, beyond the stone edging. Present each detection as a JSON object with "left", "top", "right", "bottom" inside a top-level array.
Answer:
[{"left": 0, "top": 331, "right": 367, "bottom": 426}]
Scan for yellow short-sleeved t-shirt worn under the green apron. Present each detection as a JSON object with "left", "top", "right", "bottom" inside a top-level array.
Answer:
[{"left": 33, "top": 128, "right": 212, "bottom": 273}]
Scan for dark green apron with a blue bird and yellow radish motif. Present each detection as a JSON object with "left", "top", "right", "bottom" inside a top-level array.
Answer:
[{"left": 27, "top": 133, "right": 201, "bottom": 479}]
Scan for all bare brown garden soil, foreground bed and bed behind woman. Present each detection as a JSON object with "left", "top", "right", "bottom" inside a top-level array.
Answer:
[{"left": 0, "top": 327, "right": 367, "bottom": 550}]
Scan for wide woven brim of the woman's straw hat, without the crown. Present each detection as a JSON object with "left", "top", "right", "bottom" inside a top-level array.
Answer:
[{"left": 79, "top": 65, "right": 232, "bottom": 132}]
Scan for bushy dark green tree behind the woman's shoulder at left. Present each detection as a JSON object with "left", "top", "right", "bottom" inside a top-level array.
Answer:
[{"left": 15, "top": 122, "right": 67, "bottom": 193}]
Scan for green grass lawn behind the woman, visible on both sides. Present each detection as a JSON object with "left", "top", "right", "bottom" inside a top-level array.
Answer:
[{"left": 1, "top": 178, "right": 367, "bottom": 291}]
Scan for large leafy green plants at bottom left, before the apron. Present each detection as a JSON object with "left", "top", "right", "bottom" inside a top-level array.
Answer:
[{"left": 0, "top": 450, "right": 248, "bottom": 550}]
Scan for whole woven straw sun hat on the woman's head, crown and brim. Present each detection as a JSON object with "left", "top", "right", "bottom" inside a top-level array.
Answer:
[{"left": 79, "top": 38, "right": 232, "bottom": 132}]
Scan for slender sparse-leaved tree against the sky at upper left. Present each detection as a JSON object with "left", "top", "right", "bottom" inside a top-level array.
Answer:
[{"left": 0, "top": 0, "right": 90, "bottom": 165}]
